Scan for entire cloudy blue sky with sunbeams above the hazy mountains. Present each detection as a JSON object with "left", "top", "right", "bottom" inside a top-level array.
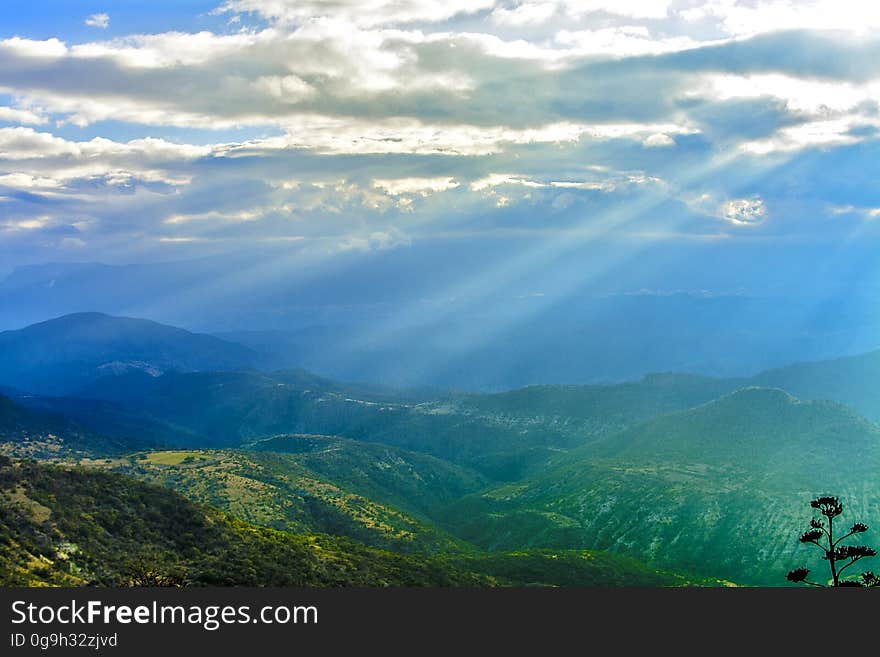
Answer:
[{"left": 0, "top": 0, "right": 880, "bottom": 294}]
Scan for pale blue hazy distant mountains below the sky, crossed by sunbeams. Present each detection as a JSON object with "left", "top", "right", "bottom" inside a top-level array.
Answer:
[{"left": 0, "top": 251, "right": 880, "bottom": 390}]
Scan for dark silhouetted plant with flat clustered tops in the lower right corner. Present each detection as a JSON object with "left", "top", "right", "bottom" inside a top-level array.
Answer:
[{"left": 786, "top": 497, "right": 880, "bottom": 588}]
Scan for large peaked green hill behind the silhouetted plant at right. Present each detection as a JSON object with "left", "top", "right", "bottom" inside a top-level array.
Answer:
[{"left": 445, "top": 389, "right": 880, "bottom": 585}]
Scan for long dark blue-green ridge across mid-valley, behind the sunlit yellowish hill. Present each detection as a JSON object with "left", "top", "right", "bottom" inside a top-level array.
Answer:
[{"left": 53, "top": 371, "right": 734, "bottom": 481}]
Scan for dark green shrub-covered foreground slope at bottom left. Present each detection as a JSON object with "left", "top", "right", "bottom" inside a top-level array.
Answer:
[{"left": 0, "top": 459, "right": 492, "bottom": 586}]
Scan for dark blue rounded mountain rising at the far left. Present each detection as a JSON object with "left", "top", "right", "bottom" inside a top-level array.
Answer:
[{"left": 0, "top": 312, "right": 260, "bottom": 395}]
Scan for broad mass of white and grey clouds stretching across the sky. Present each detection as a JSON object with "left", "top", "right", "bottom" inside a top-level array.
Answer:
[{"left": 0, "top": 0, "right": 880, "bottom": 262}]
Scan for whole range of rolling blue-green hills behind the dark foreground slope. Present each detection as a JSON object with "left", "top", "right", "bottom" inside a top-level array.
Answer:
[{"left": 0, "top": 315, "right": 880, "bottom": 585}]
